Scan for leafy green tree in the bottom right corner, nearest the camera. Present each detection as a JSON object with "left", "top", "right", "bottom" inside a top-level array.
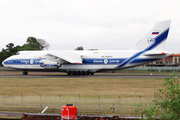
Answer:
[{"left": 135, "top": 74, "right": 180, "bottom": 120}]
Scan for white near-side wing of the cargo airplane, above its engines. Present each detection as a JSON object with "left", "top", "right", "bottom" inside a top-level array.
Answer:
[{"left": 47, "top": 51, "right": 82, "bottom": 64}]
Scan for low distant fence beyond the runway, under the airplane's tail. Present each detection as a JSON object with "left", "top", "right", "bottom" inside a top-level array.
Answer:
[{"left": 125, "top": 67, "right": 180, "bottom": 72}]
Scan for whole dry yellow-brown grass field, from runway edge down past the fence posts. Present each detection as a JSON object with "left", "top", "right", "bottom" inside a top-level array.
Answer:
[{"left": 0, "top": 72, "right": 177, "bottom": 114}]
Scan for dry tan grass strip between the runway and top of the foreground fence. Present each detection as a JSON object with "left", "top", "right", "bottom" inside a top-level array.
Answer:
[{"left": 0, "top": 78, "right": 167, "bottom": 97}]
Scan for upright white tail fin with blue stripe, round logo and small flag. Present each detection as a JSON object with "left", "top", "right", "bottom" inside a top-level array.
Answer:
[{"left": 132, "top": 20, "right": 171, "bottom": 51}]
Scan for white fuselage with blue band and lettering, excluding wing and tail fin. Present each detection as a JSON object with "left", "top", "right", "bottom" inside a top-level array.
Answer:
[{"left": 3, "top": 50, "right": 170, "bottom": 73}]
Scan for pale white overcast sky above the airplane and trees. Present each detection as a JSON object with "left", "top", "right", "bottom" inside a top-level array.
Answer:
[{"left": 0, "top": 0, "right": 180, "bottom": 53}]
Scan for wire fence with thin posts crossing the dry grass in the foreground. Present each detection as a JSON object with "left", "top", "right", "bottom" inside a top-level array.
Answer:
[{"left": 0, "top": 94, "right": 158, "bottom": 115}]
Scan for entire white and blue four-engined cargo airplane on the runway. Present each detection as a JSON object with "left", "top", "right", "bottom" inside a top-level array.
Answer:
[{"left": 3, "top": 20, "right": 173, "bottom": 75}]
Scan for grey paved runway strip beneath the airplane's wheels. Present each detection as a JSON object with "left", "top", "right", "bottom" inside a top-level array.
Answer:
[{"left": 0, "top": 71, "right": 174, "bottom": 78}]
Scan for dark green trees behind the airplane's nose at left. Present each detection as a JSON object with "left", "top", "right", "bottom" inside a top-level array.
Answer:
[{"left": 0, "top": 37, "right": 50, "bottom": 66}]
